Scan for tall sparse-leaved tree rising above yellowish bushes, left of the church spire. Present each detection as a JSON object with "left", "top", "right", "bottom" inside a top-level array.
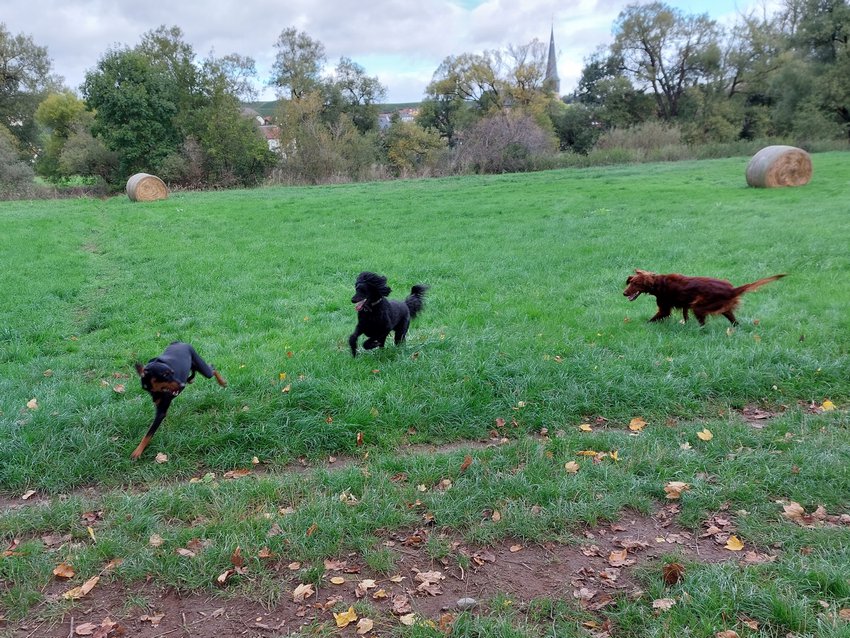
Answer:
[{"left": 269, "top": 27, "right": 325, "bottom": 99}]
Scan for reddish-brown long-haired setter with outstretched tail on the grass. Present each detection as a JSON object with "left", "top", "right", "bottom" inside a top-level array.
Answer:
[{"left": 623, "top": 269, "right": 785, "bottom": 326}]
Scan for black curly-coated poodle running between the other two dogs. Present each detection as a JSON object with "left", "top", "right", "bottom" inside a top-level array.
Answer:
[{"left": 348, "top": 272, "right": 428, "bottom": 357}]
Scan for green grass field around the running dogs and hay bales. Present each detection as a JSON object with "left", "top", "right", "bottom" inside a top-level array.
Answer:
[{"left": 0, "top": 153, "right": 850, "bottom": 637}]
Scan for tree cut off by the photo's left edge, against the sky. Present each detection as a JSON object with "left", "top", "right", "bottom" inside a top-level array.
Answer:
[{"left": 0, "top": 22, "right": 62, "bottom": 158}]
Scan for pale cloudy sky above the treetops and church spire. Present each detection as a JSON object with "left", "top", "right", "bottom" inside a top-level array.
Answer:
[{"left": 0, "top": 0, "right": 780, "bottom": 102}]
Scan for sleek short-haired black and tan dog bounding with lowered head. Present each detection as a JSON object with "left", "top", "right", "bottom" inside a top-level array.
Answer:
[{"left": 130, "top": 341, "right": 227, "bottom": 459}]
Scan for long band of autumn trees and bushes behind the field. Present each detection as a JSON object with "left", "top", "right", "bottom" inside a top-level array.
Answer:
[{"left": 0, "top": 0, "right": 850, "bottom": 196}]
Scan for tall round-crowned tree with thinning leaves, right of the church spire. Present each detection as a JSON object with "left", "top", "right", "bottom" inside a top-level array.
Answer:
[{"left": 611, "top": 2, "right": 721, "bottom": 120}]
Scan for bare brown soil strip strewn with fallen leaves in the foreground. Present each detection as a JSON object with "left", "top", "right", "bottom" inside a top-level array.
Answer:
[{"left": 0, "top": 504, "right": 756, "bottom": 638}]
